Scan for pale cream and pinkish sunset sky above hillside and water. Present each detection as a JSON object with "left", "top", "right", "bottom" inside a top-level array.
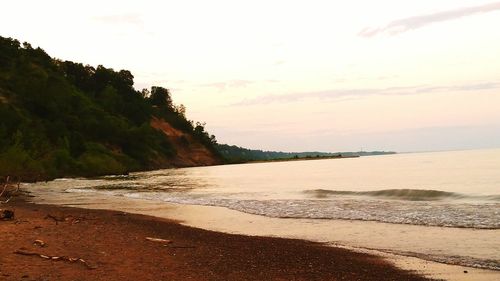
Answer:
[{"left": 0, "top": 0, "right": 500, "bottom": 152}]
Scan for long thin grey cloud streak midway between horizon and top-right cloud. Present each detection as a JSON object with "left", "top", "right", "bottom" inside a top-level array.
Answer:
[{"left": 233, "top": 82, "right": 500, "bottom": 106}]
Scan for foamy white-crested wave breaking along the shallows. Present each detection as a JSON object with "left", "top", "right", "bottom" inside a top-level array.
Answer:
[{"left": 66, "top": 185, "right": 500, "bottom": 229}]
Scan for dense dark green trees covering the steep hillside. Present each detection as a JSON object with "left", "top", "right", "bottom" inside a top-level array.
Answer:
[{"left": 0, "top": 37, "right": 219, "bottom": 179}]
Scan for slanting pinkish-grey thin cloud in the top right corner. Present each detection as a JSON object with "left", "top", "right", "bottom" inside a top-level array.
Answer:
[{"left": 358, "top": 2, "right": 500, "bottom": 38}]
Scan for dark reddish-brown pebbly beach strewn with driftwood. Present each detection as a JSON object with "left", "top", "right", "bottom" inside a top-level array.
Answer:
[{"left": 0, "top": 197, "right": 430, "bottom": 280}]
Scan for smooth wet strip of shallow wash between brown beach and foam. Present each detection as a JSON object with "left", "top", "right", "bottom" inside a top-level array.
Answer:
[{"left": 21, "top": 175, "right": 500, "bottom": 281}]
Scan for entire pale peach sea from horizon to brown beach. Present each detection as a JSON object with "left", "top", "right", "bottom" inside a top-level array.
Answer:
[{"left": 25, "top": 149, "right": 500, "bottom": 276}]
